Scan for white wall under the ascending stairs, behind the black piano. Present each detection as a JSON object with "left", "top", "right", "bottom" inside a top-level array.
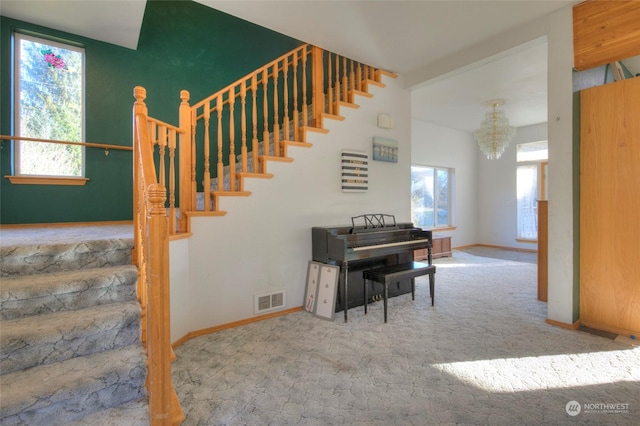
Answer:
[{"left": 171, "top": 73, "right": 411, "bottom": 341}]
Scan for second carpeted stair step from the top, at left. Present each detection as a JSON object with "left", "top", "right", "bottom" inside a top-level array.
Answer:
[{"left": 0, "top": 265, "right": 138, "bottom": 320}]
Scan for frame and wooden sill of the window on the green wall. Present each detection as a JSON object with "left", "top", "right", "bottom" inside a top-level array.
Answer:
[{"left": 7, "top": 30, "right": 88, "bottom": 185}]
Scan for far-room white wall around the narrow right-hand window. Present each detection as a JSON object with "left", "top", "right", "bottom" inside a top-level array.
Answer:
[{"left": 476, "top": 123, "right": 547, "bottom": 250}]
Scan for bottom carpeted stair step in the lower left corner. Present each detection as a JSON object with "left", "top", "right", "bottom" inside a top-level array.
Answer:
[{"left": 0, "top": 343, "right": 147, "bottom": 426}]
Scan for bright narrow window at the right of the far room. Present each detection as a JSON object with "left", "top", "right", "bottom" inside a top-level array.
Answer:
[{"left": 516, "top": 141, "right": 549, "bottom": 241}]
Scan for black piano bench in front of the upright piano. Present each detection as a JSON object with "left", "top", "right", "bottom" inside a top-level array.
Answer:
[{"left": 362, "top": 262, "right": 436, "bottom": 323}]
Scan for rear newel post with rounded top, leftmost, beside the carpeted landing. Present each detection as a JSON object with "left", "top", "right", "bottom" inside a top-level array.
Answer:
[{"left": 131, "top": 86, "right": 148, "bottom": 267}]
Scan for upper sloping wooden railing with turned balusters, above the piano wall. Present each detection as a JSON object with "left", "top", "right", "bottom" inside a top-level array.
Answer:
[{"left": 180, "top": 44, "right": 384, "bottom": 223}]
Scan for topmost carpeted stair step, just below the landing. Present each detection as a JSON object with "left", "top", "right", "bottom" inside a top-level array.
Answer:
[{"left": 0, "top": 238, "right": 133, "bottom": 277}]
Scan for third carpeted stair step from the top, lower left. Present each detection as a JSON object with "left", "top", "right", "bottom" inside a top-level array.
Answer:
[{"left": 0, "top": 300, "right": 140, "bottom": 375}]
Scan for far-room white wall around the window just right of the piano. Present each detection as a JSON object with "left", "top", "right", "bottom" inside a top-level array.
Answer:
[{"left": 411, "top": 119, "right": 478, "bottom": 247}]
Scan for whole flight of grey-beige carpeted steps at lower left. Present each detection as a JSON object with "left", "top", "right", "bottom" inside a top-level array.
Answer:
[{"left": 0, "top": 230, "right": 149, "bottom": 426}]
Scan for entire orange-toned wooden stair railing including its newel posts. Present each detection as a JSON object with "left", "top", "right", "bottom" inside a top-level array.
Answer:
[{"left": 133, "top": 44, "right": 394, "bottom": 425}]
